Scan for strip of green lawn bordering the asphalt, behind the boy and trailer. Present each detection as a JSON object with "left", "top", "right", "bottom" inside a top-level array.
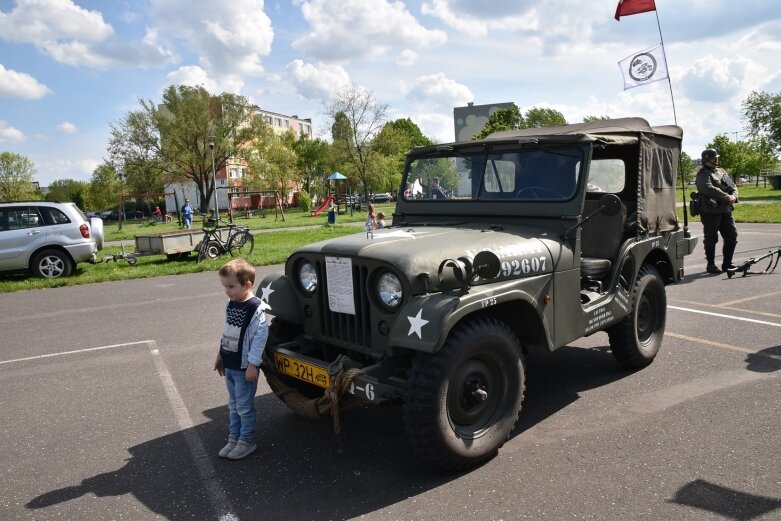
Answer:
[{"left": 0, "top": 224, "right": 362, "bottom": 292}]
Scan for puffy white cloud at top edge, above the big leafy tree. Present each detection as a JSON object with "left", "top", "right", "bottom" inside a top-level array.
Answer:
[{"left": 147, "top": 0, "right": 274, "bottom": 82}]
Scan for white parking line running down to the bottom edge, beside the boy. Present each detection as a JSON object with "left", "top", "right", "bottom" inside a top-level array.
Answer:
[{"left": 149, "top": 341, "right": 239, "bottom": 521}]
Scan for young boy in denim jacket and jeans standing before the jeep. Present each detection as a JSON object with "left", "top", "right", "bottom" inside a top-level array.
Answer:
[{"left": 214, "top": 259, "right": 268, "bottom": 459}]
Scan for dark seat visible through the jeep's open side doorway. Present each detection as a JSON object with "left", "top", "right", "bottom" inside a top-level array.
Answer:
[{"left": 580, "top": 200, "right": 626, "bottom": 280}]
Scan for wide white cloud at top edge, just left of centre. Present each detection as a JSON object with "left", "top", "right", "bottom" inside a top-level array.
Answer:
[{"left": 293, "top": 0, "right": 447, "bottom": 61}]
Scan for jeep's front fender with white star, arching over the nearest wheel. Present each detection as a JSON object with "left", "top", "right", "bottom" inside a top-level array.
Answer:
[{"left": 388, "top": 281, "right": 548, "bottom": 353}]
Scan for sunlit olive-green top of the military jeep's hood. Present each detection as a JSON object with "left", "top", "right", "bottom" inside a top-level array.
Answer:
[{"left": 297, "top": 226, "right": 558, "bottom": 279}]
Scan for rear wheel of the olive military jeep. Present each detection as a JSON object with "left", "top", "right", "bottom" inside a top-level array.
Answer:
[{"left": 607, "top": 264, "right": 667, "bottom": 369}]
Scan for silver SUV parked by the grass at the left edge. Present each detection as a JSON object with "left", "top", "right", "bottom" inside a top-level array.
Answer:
[{"left": 0, "top": 201, "right": 103, "bottom": 278}]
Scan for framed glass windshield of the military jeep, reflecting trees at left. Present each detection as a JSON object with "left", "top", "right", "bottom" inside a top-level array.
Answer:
[{"left": 402, "top": 145, "right": 585, "bottom": 203}]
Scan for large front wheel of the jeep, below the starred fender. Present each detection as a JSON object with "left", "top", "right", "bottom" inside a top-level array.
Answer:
[{"left": 404, "top": 318, "right": 525, "bottom": 470}]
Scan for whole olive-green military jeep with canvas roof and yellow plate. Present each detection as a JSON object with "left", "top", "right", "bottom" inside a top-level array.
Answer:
[{"left": 260, "top": 118, "right": 696, "bottom": 470}]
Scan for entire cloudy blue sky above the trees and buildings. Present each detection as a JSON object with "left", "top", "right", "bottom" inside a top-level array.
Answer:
[{"left": 0, "top": 0, "right": 781, "bottom": 185}]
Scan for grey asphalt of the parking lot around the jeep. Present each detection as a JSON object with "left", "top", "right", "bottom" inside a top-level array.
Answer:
[{"left": 0, "top": 222, "right": 781, "bottom": 521}]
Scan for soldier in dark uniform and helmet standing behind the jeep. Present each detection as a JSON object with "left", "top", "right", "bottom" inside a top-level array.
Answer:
[{"left": 696, "top": 148, "right": 738, "bottom": 274}]
